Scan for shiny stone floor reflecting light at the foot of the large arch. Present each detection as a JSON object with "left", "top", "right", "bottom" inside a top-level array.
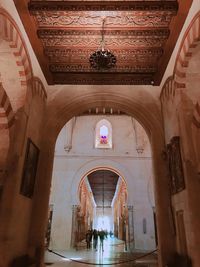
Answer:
[{"left": 45, "top": 238, "right": 157, "bottom": 267}]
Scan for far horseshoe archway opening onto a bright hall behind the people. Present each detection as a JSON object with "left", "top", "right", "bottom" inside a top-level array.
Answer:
[{"left": 75, "top": 168, "right": 128, "bottom": 245}]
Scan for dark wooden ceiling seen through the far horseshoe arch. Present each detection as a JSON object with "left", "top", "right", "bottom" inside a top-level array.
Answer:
[{"left": 88, "top": 170, "right": 119, "bottom": 207}]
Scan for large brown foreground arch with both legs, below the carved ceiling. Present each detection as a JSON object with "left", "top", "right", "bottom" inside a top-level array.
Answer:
[{"left": 27, "top": 89, "right": 174, "bottom": 264}]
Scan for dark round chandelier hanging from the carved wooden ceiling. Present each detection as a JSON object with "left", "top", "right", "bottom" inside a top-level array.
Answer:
[{"left": 89, "top": 18, "right": 117, "bottom": 70}]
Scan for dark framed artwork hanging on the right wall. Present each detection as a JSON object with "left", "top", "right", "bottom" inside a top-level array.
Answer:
[{"left": 167, "top": 136, "right": 185, "bottom": 194}]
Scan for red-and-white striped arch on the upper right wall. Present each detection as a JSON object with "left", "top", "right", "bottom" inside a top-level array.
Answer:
[{"left": 160, "top": 11, "right": 200, "bottom": 144}]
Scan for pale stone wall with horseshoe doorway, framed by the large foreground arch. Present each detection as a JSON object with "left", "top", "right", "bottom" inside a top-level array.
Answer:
[{"left": 44, "top": 108, "right": 155, "bottom": 266}]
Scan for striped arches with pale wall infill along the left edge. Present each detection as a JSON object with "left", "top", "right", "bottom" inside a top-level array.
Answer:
[{"left": 0, "top": 7, "right": 32, "bottom": 185}]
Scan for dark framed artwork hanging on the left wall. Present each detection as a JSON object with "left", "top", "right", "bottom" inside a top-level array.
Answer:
[{"left": 20, "top": 138, "right": 40, "bottom": 198}]
